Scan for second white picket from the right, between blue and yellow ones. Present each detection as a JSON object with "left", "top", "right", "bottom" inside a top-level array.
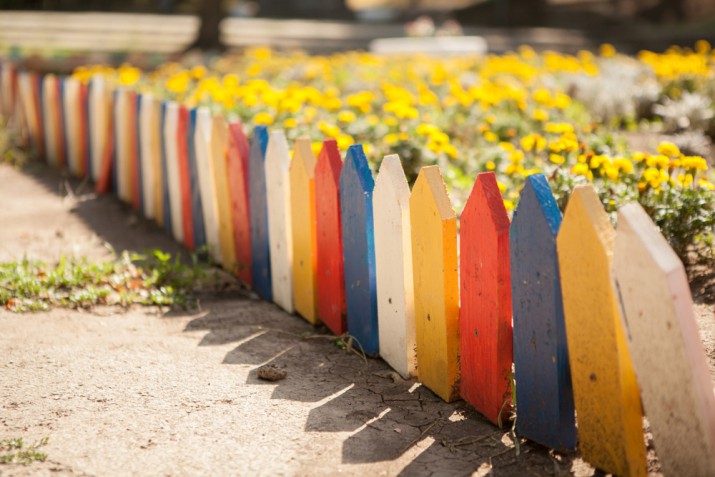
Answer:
[{"left": 373, "top": 154, "right": 417, "bottom": 378}]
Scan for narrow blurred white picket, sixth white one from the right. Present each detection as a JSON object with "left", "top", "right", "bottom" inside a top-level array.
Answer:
[{"left": 137, "top": 93, "right": 160, "bottom": 219}]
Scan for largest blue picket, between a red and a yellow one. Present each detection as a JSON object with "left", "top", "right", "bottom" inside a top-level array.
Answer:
[{"left": 509, "top": 174, "right": 576, "bottom": 450}]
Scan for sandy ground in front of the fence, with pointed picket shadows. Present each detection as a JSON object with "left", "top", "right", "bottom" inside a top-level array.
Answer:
[{"left": 0, "top": 165, "right": 715, "bottom": 476}]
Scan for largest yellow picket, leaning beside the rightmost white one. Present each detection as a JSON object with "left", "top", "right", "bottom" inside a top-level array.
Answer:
[{"left": 556, "top": 184, "right": 646, "bottom": 476}]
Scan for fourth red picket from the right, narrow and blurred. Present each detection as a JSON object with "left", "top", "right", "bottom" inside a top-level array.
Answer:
[{"left": 173, "top": 105, "right": 194, "bottom": 250}]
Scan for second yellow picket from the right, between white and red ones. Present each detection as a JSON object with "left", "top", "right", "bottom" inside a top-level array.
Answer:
[{"left": 410, "top": 166, "right": 459, "bottom": 402}]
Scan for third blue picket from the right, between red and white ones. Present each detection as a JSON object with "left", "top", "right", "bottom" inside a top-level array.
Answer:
[{"left": 248, "top": 126, "right": 273, "bottom": 300}]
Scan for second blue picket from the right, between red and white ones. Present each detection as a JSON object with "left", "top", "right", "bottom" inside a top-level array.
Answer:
[{"left": 340, "top": 144, "right": 380, "bottom": 355}]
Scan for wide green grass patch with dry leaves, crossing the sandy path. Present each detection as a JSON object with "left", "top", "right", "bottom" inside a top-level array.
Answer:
[{"left": 0, "top": 249, "right": 209, "bottom": 312}]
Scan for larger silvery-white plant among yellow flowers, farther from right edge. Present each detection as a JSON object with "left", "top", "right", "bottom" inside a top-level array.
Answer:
[{"left": 569, "top": 58, "right": 660, "bottom": 121}]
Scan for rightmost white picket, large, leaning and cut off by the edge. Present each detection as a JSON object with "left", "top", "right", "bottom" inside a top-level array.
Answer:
[{"left": 613, "top": 203, "right": 715, "bottom": 477}]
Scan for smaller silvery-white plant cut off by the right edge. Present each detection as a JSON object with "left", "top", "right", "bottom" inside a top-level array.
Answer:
[{"left": 653, "top": 92, "right": 715, "bottom": 133}]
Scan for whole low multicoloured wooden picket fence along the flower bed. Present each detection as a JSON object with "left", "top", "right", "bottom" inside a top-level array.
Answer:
[{"left": 0, "top": 63, "right": 715, "bottom": 476}]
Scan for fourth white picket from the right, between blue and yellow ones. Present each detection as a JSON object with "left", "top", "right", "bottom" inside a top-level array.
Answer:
[{"left": 194, "top": 107, "right": 221, "bottom": 263}]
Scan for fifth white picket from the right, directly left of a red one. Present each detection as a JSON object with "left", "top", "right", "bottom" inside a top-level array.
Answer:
[{"left": 162, "top": 101, "right": 184, "bottom": 243}]
